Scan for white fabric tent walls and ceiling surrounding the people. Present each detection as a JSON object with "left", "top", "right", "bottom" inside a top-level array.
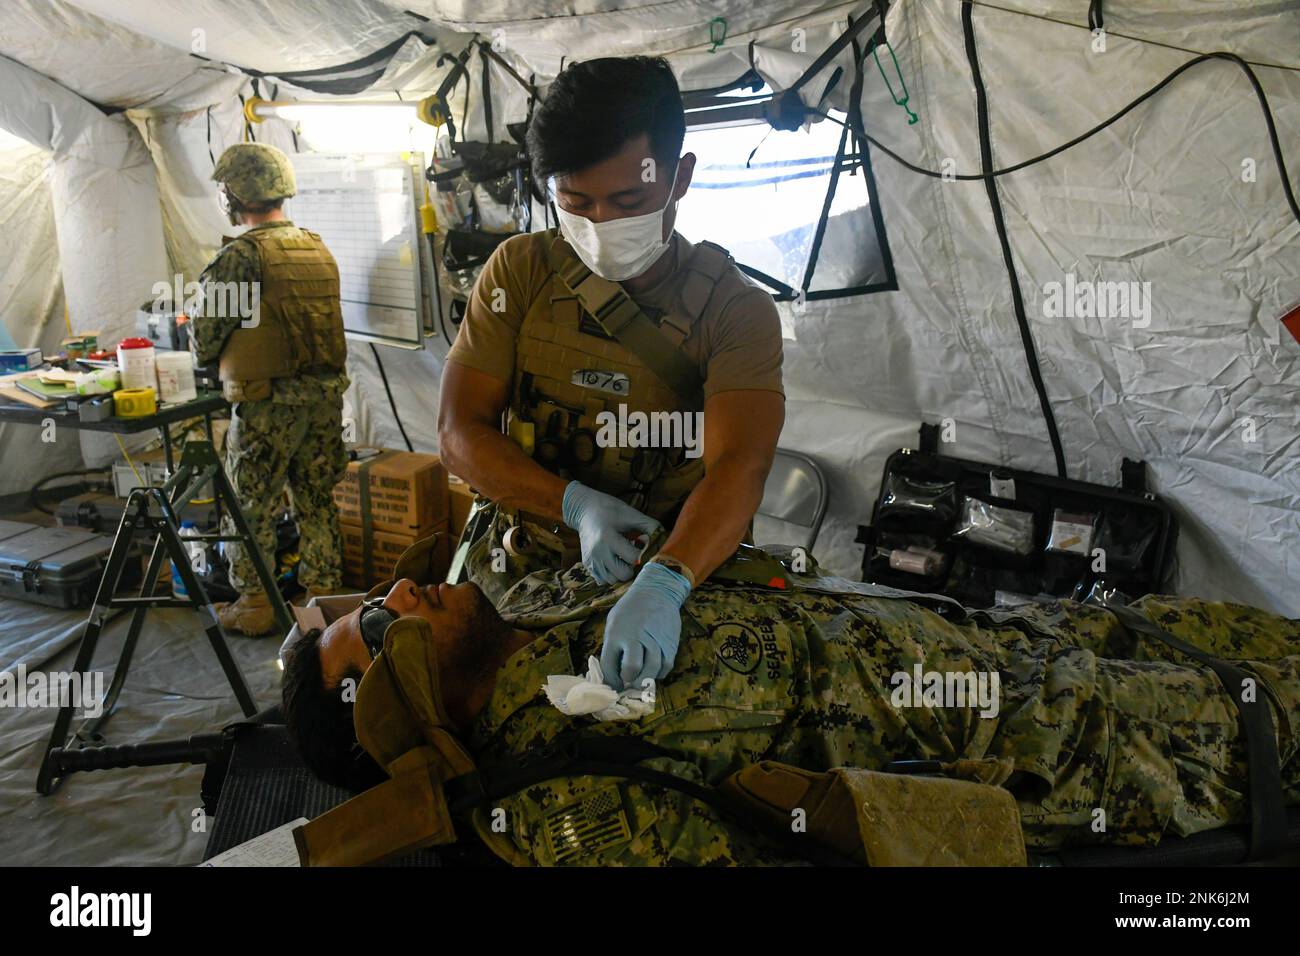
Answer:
[{"left": 0, "top": 0, "right": 1300, "bottom": 615}]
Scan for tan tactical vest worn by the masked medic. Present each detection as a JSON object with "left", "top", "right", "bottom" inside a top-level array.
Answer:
[{"left": 507, "top": 229, "right": 733, "bottom": 522}]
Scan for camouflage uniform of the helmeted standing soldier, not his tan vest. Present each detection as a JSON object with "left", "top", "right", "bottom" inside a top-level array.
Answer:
[{"left": 190, "top": 220, "right": 348, "bottom": 593}]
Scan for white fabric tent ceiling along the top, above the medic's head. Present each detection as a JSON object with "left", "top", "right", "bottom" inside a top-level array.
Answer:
[{"left": 0, "top": 0, "right": 1300, "bottom": 109}]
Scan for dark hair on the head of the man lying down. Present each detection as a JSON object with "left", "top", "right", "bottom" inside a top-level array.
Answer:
[{"left": 281, "top": 627, "right": 387, "bottom": 792}]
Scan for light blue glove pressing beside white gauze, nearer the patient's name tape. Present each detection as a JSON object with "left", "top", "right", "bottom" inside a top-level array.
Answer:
[{"left": 601, "top": 562, "right": 690, "bottom": 691}]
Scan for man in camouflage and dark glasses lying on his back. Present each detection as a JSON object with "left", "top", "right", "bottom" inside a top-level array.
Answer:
[{"left": 283, "top": 561, "right": 1300, "bottom": 865}]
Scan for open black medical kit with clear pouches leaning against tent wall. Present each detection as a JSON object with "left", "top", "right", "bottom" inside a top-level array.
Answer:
[{"left": 857, "top": 425, "right": 1178, "bottom": 607}]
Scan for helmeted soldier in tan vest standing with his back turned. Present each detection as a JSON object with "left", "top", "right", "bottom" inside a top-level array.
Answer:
[{"left": 190, "top": 143, "right": 348, "bottom": 636}]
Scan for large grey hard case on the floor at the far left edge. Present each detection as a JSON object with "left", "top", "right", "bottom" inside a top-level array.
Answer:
[{"left": 0, "top": 522, "right": 142, "bottom": 609}]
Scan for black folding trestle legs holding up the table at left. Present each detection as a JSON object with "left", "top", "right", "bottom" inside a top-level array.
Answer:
[{"left": 36, "top": 441, "right": 293, "bottom": 795}]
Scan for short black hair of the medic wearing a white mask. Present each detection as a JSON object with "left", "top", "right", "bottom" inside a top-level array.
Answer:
[{"left": 528, "top": 56, "right": 686, "bottom": 190}]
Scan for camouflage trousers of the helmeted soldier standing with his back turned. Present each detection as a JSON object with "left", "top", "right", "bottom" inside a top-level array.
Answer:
[{"left": 222, "top": 401, "right": 347, "bottom": 593}]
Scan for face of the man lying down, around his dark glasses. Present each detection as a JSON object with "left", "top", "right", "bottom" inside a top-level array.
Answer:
[{"left": 320, "top": 578, "right": 497, "bottom": 685}]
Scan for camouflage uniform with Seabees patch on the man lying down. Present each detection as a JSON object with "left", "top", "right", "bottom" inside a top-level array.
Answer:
[{"left": 471, "top": 571, "right": 1300, "bottom": 865}]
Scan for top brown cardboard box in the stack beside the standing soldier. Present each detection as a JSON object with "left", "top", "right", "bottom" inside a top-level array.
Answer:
[{"left": 334, "top": 449, "right": 449, "bottom": 538}]
